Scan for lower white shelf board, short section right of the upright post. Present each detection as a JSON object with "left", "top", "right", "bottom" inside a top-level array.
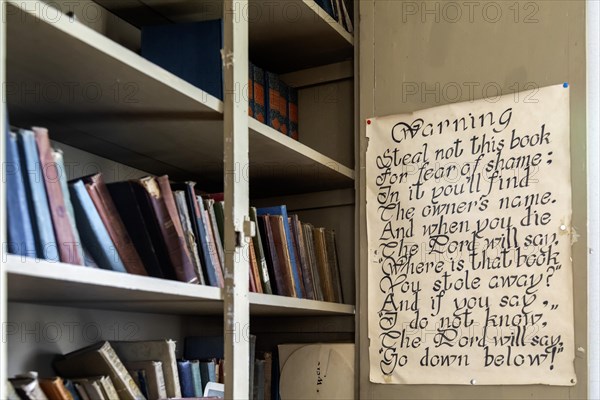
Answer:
[{"left": 248, "top": 293, "right": 354, "bottom": 317}]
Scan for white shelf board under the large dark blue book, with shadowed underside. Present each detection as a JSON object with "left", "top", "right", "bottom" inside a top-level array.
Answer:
[{"left": 7, "top": 0, "right": 354, "bottom": 196}]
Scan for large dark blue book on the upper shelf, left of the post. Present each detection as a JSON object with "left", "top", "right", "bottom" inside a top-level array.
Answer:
[{"left": 142, "top": 19, "right": 223, "bottom": 100}]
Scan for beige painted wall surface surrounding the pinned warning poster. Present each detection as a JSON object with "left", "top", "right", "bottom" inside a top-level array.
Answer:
[{"left": 357, "top": 0, "right": 588, "bottom": 399}]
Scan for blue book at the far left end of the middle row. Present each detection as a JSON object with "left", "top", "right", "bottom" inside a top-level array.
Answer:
[{"left": 4, "top": 119, "right": 37, "bottom": 257}]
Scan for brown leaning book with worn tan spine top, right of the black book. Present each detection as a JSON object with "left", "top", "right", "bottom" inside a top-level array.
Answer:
[{"left": 140, "top": 175, "right": 198, "bottom": 283}]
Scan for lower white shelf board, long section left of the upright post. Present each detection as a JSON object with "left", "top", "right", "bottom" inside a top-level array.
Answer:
[{"left": 3, "top": 255, "right": 223, "bottom": 314}]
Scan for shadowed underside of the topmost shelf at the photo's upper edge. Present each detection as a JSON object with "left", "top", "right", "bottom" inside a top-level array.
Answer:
[{"left": 96, "top": 0, "right": 354, "bottom": 73}]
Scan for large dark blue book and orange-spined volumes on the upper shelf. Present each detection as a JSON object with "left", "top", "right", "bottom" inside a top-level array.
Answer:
[{"left": 141, "top": 19, "right": 298, "bottom": 140}]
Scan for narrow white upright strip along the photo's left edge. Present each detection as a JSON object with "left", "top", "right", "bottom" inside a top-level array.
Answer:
[{"left": 0, "top": 0, "right": 8, "bottom": 399}]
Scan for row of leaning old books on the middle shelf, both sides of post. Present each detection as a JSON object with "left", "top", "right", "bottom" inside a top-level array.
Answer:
[{"left": 6, "top": 123, "right": 343, "bottom": 302}]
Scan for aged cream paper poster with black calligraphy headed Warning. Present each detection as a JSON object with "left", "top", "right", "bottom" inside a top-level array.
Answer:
[{"left": 366, "top": 85, "right": 576, "bottom": 385}]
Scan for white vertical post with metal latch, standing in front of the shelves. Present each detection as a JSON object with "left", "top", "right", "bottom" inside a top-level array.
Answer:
[{"left": 221, "top": 0, "right": 250, "bottom": 399}]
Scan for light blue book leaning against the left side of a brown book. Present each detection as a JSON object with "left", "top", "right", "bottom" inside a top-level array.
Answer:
[{"left": 69, "top": 179, "right": 126, "bottom": 272}]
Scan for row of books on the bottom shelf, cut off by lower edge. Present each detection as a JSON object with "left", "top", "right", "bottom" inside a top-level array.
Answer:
[{"left": 8, "top": 335, "right": 278, "bottom": 400}]
